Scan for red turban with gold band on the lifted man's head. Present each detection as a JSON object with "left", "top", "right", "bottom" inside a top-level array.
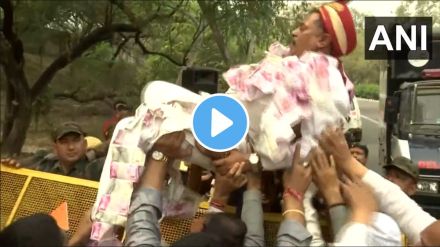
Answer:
[{"left": 319, "top": 1, "right": 356, "bottom": 57}]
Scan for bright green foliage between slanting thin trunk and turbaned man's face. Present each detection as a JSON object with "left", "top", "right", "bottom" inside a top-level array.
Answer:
[{"left": 197, "top": 0, "right": 310, "bottom": 67}]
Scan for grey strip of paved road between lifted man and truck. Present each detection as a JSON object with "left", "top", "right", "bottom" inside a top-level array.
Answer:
[{"left": 358, "top": 99, "right": 382, "bottom": 173}]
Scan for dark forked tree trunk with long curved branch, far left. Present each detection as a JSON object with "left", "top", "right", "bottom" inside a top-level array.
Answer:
[{"left": 0, "top": 0, "right": 139, "bottom": 154}]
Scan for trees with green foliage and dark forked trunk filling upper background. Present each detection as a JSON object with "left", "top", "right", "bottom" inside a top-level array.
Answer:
[{"left": 0, "top": 0, "right": 306, "bottom": 154}]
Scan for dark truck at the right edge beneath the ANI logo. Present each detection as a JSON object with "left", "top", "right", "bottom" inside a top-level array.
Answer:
[{"left": 379, "top": 31, "right": 440, "bottom": 219}]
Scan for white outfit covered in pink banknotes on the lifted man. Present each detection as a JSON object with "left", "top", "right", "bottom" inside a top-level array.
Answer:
[{"left": 92, "top": 45, "right": 350, "bottom": 240}]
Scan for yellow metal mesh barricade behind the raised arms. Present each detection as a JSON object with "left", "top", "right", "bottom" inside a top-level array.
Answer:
[{"left": 0, "top": 165, "right": 281, "bottom": 246}]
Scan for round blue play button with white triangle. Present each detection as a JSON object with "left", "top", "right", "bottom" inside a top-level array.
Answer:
[{"left": 192, "top": 94, "right": 249, "bottom": 152}]
